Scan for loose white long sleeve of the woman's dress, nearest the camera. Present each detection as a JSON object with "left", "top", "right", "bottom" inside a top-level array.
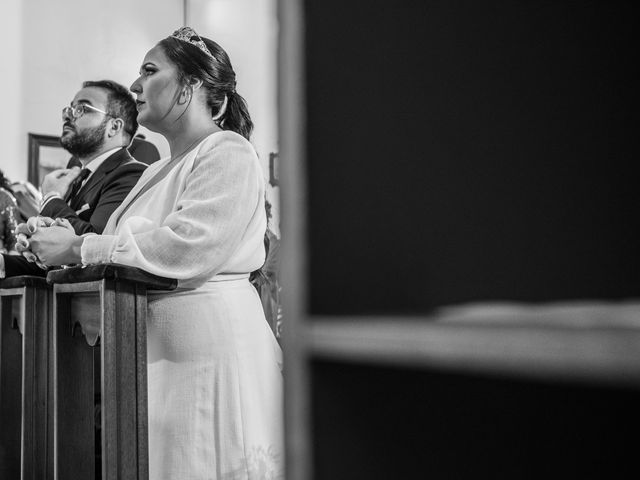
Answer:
[{"left": 82, "top": 138, "right": 265, "bottom": 280}]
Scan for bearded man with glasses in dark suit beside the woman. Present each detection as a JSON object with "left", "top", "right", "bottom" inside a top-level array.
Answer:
[{"left": 0, "top": 80, "right": 147, "bottom": 278}]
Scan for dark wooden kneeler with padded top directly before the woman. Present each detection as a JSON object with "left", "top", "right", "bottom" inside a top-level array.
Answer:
[{"left": 47, "top": 264, "right": 177, "bottom": 480}]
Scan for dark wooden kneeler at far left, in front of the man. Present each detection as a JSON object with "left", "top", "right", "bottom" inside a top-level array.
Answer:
[{"left": 0, "top": 276, "right": 53, "bottom": 480}]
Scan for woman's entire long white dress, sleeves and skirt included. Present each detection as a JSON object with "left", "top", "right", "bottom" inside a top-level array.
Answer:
[{"left": 82, "top": 131, "right": 283, "bottom": 480}]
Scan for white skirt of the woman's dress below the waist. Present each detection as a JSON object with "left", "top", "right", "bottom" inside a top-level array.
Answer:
[{"left": 147, "top": 275, "right": 283, "bottom": 480}]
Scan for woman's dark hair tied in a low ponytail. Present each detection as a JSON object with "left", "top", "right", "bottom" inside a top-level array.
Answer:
[{"left": 158, "top": 37, "right": 253, "bottom": 140}]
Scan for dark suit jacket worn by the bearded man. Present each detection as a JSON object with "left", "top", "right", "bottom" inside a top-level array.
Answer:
[{"left": 4, "top": 148, "right": 147, "bottom": 277}]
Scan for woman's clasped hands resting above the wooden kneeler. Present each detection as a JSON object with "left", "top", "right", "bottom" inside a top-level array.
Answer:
[{"left": 16, "top": 217, "right": 81, "bottom": 268}]
